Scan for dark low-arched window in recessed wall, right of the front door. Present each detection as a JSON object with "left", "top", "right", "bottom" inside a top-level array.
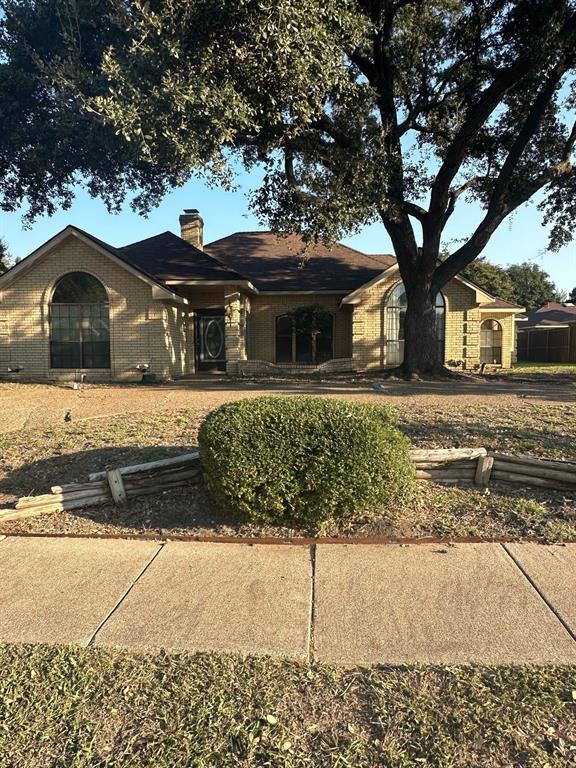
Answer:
[{"left": 276, "top": 307, "right": 334, "bottom": 365}]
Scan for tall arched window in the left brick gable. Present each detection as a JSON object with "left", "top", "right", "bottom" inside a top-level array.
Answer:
[{"left": 50, "top": 272, "right": 110, "bottom": 368}]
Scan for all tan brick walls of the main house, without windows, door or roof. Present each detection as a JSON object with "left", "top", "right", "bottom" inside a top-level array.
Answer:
[{"left": 0, "top": 236, "right": 515, "bottom": 381}]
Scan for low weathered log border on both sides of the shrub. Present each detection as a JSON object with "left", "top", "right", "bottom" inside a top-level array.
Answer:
[{"left": 0, "top": 440, "right": 576, "bottom": 522}]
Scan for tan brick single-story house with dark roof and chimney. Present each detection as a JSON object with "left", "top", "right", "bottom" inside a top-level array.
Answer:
[{"left": 0, "top": 209, "right": 522, "bottom": 381}]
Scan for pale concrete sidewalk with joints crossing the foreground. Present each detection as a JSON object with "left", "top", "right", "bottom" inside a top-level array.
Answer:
[{"left": 0, "top": 537, "right": 576, "bottom": 665}]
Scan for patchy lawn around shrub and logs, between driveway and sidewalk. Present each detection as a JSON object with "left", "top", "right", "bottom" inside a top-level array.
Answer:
[{"left": 0, "top": 398, "right": 576, "bottom": 541}]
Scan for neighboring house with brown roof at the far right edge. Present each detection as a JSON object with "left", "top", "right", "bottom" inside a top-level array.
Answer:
[{"left": 518, "top": 301, "right": 576, "bottom": 363}]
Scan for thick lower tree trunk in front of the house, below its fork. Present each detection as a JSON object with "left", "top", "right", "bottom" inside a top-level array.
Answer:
[{"left": 400, "top": 280, "right": 445, "bottom": 378}]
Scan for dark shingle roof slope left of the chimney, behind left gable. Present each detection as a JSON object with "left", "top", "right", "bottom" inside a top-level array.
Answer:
[{"left": 116, "top": 232, "right": 245, "bottom": 281}]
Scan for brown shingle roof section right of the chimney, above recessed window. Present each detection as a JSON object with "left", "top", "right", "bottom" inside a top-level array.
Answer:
[{"left": 205, "top": 232, "right": 396, "bottom": 293}]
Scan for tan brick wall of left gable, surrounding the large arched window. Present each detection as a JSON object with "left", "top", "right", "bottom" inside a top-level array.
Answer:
[{"left": 0, "top": 236, "right": 192, "bottom": 381}]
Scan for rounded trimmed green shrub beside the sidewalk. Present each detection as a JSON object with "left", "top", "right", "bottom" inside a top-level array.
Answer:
[{"left": 199, "top": 396, "right": 415, "bottom": 525}]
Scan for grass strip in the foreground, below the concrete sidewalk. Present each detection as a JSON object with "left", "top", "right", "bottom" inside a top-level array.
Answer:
[{"left": 0, "top": 645, "right": 576, "bottom": 768}]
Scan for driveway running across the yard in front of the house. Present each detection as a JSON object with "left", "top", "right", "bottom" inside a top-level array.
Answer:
[{"left": 0, "top": 376, "right": 576, "bottom": 432}]
